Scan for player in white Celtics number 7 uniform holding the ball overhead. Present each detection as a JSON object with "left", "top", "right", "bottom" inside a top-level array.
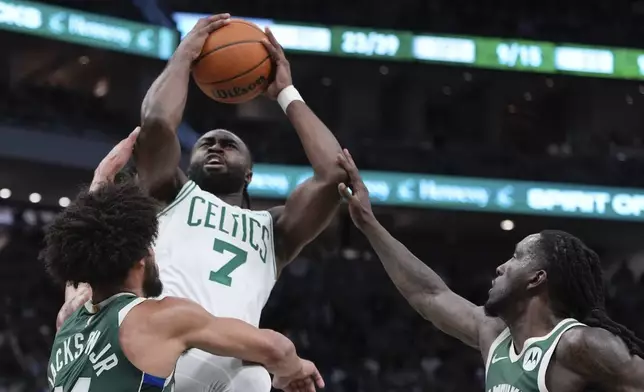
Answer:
[{"left": 134, "top": 14, "right": 346, "bottom": 392}]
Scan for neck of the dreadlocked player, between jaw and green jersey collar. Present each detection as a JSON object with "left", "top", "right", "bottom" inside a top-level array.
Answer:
[{"left": 505, "top": 300, "right": 561, "bottom": 352}]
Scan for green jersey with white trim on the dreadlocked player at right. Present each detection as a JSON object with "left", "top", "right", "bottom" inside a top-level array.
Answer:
[{"left": 485, "top": 319, "right": 584, "bottom": 392}]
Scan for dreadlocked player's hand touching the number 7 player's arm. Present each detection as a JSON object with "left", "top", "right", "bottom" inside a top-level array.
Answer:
[{"left": 338, "top": 148, "right": 376, "bottom": 229}]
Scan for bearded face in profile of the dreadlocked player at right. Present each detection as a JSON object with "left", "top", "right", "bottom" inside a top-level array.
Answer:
[{"left": 484, "top": 234, "right": 544, "bottom": 317}]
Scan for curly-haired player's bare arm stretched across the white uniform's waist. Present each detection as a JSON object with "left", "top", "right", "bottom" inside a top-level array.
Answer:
[{"left": 126, "top": 297, "right": 324, "bottom": 392}]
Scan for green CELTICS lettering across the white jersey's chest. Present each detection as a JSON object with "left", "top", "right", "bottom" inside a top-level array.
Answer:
[{"left": 186, "top": 196, "right": 271, "bottom": 263}]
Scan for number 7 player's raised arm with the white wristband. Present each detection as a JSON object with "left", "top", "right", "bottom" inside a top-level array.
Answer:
[{"left": 264, "top": 29, "right": 346, "bottom": 267}]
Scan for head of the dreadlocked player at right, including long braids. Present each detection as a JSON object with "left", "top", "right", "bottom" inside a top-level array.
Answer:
[{"left": 485, "top": 230, "right": 644, "bottom": 356}]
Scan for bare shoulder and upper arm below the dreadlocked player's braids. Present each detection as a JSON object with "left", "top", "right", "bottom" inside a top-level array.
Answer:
[{"left": 556, "top": 327, "right": 644, "bottom": 392}]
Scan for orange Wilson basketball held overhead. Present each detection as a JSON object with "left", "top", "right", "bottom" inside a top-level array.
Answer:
[{"left": 192, "top": 19, "right": 273, "bottom": 104}]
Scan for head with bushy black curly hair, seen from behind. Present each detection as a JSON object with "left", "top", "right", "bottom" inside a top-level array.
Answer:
[{"left": 41, "top": 181, "right": 162, "bottom": 297}]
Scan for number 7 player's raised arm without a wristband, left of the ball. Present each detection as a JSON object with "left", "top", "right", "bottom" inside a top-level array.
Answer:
[{"left": 135, "top": 14, "right": 230, "bottom": 202}]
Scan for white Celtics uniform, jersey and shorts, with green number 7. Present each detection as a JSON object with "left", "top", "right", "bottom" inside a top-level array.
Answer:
[{"left": 154, "top": 181, "right": 277, "bottom": 392}]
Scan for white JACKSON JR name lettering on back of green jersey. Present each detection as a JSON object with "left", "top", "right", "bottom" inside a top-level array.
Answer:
[{"left": 49, "top": 331, "right": 119, "bottom": 385}]
